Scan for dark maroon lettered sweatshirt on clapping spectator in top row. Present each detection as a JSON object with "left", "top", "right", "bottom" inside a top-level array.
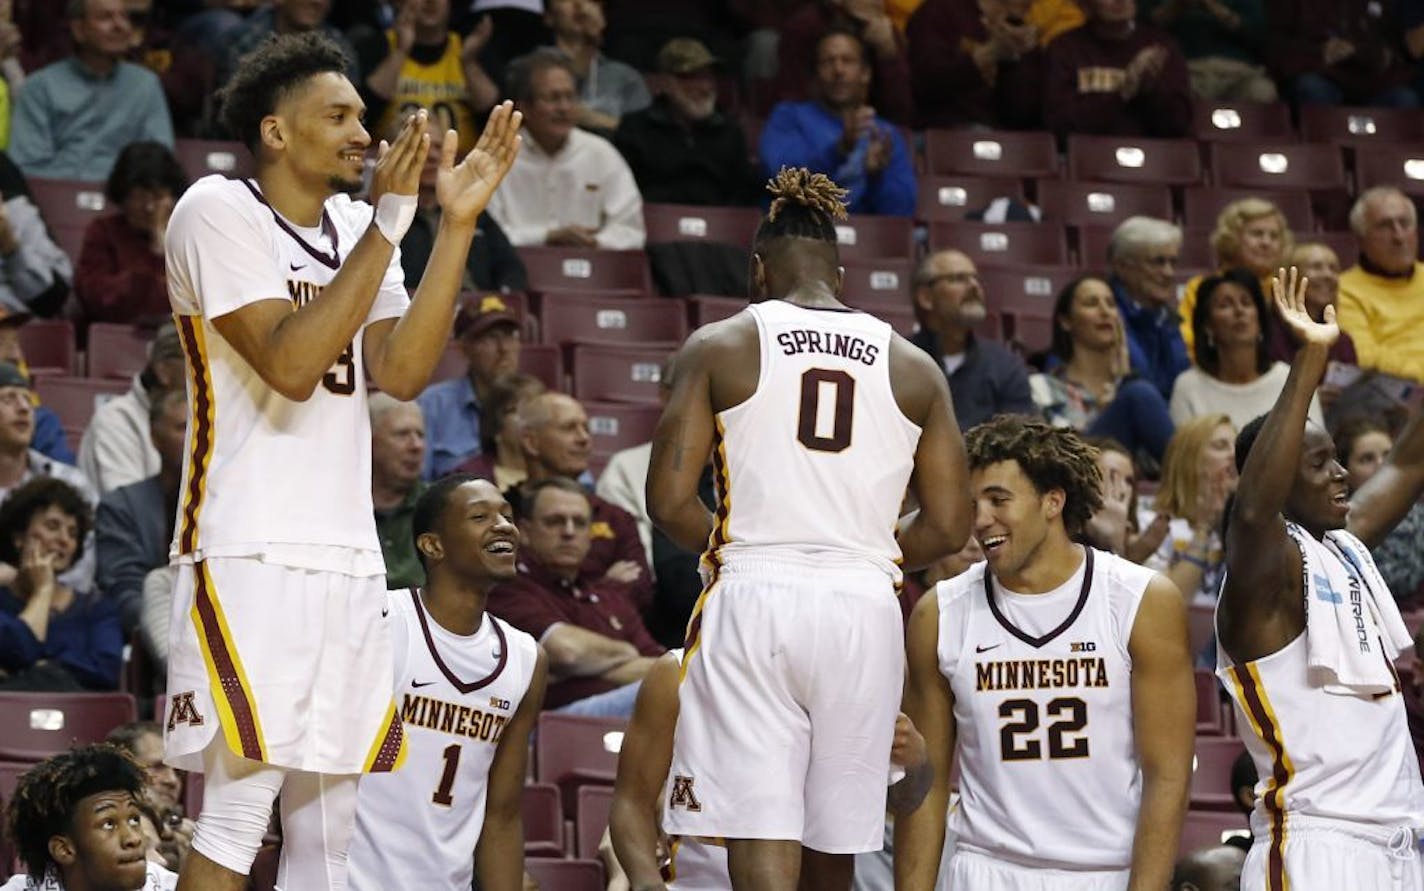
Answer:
[{"left": 1044, "top": 24, "right": 1192, "bottom": 137}]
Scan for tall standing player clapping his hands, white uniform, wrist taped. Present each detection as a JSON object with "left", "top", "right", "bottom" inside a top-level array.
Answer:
[{"left": 165, "top": 34, "right": 518, "bottom": 891}]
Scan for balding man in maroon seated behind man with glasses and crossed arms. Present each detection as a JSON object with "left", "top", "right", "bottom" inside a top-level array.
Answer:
[{"left": 510, "top": 393, "right": 652, "bottom": 612}]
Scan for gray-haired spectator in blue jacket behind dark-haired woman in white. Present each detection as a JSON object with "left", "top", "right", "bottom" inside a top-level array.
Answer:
[{"left": 1108, "top": 216, "right": 1192, "bottom": 399}]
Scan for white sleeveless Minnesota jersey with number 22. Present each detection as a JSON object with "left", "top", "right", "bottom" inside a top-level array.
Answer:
[{"left": 936, "top": 548, "right": 1153, "bottom": 870}]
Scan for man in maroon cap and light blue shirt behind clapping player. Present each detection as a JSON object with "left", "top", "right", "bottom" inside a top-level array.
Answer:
[{"left": 416, "top": 295, "right": 520, "bottom": 480}]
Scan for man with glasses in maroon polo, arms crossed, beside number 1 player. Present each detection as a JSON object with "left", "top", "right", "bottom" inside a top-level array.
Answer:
[{"left": 488, "top": 477, "right": 664, "bottom": 717}]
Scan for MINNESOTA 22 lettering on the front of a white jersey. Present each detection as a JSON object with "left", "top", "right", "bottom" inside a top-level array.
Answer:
[{"left": 974, "top": 643, "right": 1108, "bottom": 761}]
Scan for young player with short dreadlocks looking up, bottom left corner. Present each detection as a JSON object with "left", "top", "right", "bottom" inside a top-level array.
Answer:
[{"left": 0, "top": 744, "right": 178, "bottom": 891}]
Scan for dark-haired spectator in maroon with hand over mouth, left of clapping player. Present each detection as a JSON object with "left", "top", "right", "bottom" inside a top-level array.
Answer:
[{"left": 74, "top": 142, "right": 188, "bottom": 330}]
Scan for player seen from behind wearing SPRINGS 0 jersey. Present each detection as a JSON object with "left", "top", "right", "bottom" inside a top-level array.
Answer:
[{"left": 648, "top": 168, "right": 968, "bottom": 891}]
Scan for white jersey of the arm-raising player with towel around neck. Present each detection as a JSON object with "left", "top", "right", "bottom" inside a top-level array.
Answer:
[{"left": 1216, "top": 527, "right": 1424, "bottom": 844}]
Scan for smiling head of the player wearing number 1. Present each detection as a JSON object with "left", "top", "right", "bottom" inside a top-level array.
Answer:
[{"left": 432, "top": 480, "right": 520, "bottom": 581}]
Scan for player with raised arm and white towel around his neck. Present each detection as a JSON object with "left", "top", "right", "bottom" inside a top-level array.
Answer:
[{"left": 1216, "top": 268, "right": 1424, "bottom": 891}]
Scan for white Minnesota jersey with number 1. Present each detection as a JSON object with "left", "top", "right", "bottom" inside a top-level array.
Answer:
[{"left": 349, "top": 589, "right": 538, "bottom": 891}]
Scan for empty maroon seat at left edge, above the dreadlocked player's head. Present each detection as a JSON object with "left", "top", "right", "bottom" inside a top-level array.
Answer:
[{"left": 0, "top": 692, "right": 138, "bottom": 761}]
